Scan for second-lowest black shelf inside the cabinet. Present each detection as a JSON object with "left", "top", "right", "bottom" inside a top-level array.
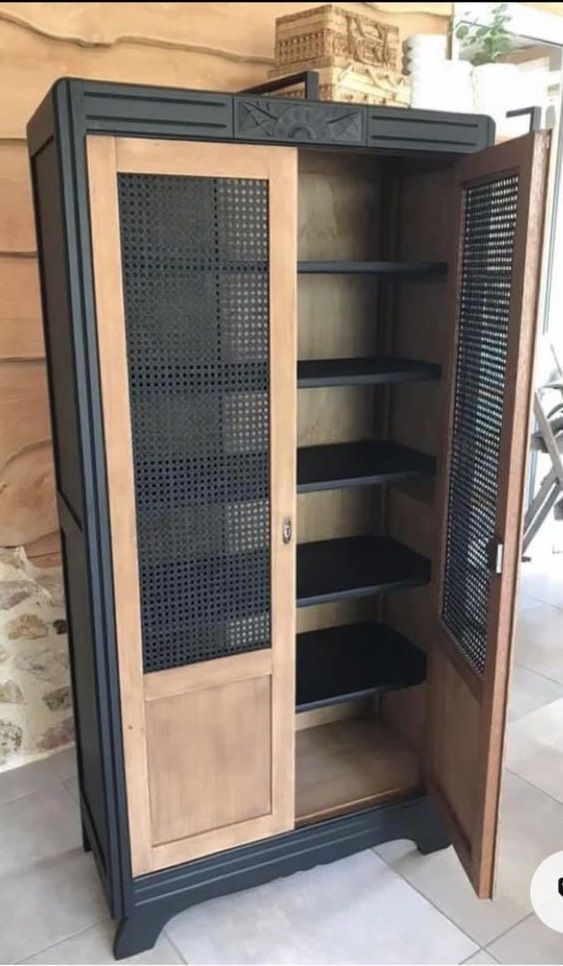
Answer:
[{"left": 297, "top": 536, "right": 430, "bottom": 607}]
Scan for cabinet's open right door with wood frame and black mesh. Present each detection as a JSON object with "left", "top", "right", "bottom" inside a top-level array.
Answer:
[{"left": 425, "top": 133, "right": 548, "bottom": 897}]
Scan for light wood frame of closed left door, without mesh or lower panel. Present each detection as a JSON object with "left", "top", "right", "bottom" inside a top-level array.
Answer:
[{"left": 86, "top": 135, "right": 297, "bottom": 875}]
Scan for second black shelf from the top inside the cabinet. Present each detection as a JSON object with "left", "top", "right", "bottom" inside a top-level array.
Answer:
[{"left": 297, "top": 357, "right": 440, "bottom": 389}]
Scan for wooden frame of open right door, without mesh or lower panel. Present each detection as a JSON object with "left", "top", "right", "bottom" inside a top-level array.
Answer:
[{"left": 425, "top": 132, "right": 549, "bottom": 897}]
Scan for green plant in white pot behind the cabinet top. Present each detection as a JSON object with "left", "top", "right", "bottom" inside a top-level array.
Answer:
[{"left": 455, "top": 3, "right": 519, "bottom": 133}]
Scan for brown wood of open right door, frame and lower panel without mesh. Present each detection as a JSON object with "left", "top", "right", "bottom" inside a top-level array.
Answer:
[{"left": 425, "top": 132, "right": 548, "bottom": 898}]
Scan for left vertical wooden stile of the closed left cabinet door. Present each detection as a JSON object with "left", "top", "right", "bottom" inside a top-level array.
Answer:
[{"left": 87, "top": 137, "right": 151, "bottom": 875}]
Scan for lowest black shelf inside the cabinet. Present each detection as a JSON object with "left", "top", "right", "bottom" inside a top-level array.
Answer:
[{"left": 296, "top": 623, "right": 426, "bottom": 711}]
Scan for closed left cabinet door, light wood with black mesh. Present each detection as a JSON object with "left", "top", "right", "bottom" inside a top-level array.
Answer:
[{"left": 87, "top": 136, "right": 297, "bottom": 875}]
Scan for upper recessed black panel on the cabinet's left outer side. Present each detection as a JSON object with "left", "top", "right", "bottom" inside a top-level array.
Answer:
[{"left": 32, "top": 141, "right": 84, "bottom": 520}]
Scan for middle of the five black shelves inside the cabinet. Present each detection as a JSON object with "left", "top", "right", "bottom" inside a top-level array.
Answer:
[{"left": 297, "top": 441, "right": 436, "bottom": 493}]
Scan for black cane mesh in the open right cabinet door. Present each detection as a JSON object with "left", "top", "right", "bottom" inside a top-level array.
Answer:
[{"left": 442, "top": 175, "right": 518, "bottom": 673}]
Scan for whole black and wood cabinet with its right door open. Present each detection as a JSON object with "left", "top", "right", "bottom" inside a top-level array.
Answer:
[{"left": 29, "top": 81, "right": 547, "bottom": 956}]
